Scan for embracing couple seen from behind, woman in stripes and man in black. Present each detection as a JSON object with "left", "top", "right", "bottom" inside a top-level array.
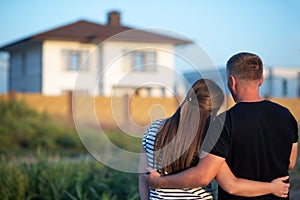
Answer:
[{"left": 139, "top": 53, "right": 298, "bottom": 200}]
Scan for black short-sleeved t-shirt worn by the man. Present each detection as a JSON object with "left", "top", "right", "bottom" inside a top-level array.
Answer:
[{"left": 210, "top": 100, "right": 298, "bottom": 200}]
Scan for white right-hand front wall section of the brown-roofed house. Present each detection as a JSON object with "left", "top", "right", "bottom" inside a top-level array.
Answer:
[{"left": 102, "top": 41, "right": 175, "bottom": 96}]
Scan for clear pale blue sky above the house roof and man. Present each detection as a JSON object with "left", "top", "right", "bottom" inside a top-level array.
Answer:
[{"left": 0, "top": 0, "right": 300, "bottom": 90}]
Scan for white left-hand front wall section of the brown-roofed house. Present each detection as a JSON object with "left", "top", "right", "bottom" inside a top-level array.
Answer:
[{"left": 42, "top": 41, "right": 98, "bottom": 95}]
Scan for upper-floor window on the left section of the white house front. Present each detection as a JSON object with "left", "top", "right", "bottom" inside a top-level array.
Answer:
[{"left": 63, "top": 50, "right": 88, "bottom": 71}]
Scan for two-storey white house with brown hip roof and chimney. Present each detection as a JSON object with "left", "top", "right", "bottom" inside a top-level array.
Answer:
[{"left": 0, "top": 11, "right": 191, "bottom": 96}]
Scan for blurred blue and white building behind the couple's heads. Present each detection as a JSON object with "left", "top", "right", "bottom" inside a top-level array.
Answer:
[{"left": 184, "top": 66, "right": 300, "bottom": 98}]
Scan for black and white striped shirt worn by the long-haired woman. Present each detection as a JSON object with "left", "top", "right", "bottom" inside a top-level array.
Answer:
[{"left": 142, "top": 120, "right": 213, "bottom": 200}]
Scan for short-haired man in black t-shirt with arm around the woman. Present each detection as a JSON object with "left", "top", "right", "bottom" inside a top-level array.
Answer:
[{"left": 145, "top": 53, "right": 298, "bottom": 200}]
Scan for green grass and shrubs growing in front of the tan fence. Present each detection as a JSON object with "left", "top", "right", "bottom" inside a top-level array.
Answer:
[{"left": 0, "top": 100, "right": 300, "bottom": 200}]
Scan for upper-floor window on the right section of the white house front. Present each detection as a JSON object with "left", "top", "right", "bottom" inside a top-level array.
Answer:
[{"left": 124, "top": 51, "right": 157, "bottom": 72}]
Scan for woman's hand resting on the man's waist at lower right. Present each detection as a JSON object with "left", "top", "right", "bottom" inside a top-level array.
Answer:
[{"left": 271, "top": 176, "right": 290, "bottom": 198}]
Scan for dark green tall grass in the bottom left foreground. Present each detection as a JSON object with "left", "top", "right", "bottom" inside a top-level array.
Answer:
[{"left": 0, "top": 154, "right": 139, "bottom": 200}]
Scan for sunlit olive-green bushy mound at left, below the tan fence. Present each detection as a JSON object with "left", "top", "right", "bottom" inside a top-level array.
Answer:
[{"left": 0, "top": 100, "right": 83, "bottom": 153}]
